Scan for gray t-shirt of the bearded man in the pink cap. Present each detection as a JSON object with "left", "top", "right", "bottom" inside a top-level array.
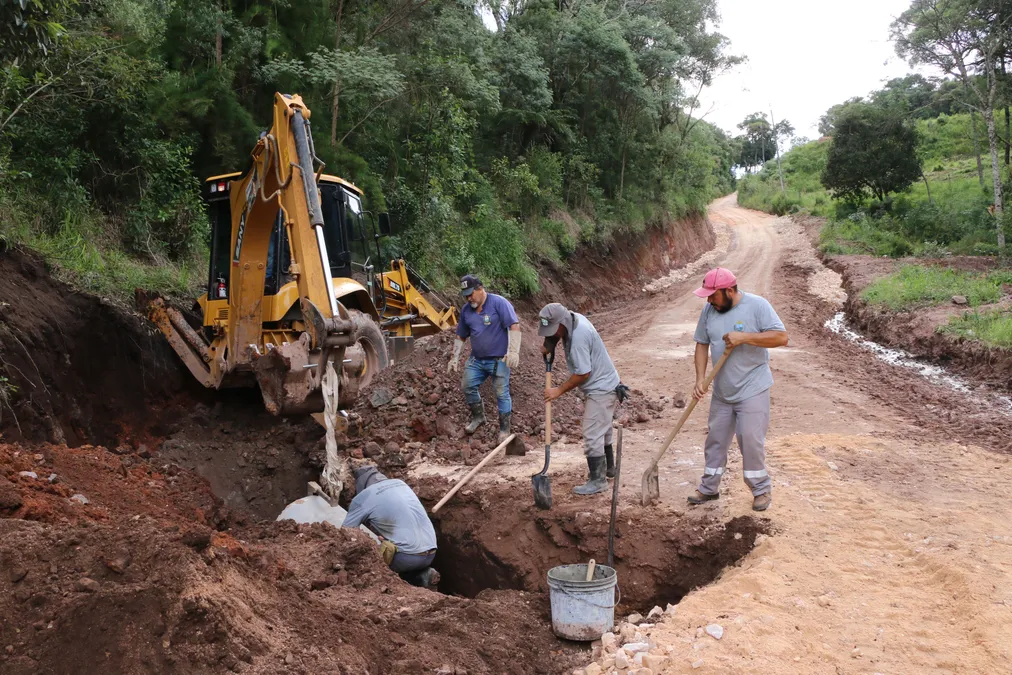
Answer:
[{"left": 693, "top": 293, "right": 784, "bottom": 403}]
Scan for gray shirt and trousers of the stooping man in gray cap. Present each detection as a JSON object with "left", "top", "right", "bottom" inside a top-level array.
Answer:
[{"left": 564, "top": 312, "right": 619, "bottom": 457}]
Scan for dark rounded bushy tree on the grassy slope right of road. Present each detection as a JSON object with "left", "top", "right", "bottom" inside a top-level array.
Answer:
[{"left": 821, "top": 103, "right": 921, "bottom": 201}]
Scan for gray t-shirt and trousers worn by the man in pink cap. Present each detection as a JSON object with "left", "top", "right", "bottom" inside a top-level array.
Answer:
[{"left": 693, "top": 293, "right": 784, "bottom": 496}]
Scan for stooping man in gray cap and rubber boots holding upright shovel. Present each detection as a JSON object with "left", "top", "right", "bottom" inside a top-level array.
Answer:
[{"left": 537, "top": 303, "right": 626, "bottom": 495}]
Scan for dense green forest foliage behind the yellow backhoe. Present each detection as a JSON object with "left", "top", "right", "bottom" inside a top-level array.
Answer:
[{"left": 0, "top": 0, "right": 740, "bottom": 293}]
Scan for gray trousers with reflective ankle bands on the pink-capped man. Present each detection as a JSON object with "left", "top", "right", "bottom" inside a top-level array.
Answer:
[{"left": 699, "top": 390, "right": 772, "bottom": 496}]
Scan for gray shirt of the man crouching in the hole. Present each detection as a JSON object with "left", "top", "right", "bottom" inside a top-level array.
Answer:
[{"left": 344, "top": 479, "right": 436, "bottom": 554}]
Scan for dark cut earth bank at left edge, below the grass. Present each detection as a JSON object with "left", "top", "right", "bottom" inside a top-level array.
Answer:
[{"left": 0, "top": 249, "right": 192, "bottom": 446}]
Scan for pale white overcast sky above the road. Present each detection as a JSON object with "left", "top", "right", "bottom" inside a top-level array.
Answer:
[{"left": 701, "top": 0, "right": 930, "bottom": 140}]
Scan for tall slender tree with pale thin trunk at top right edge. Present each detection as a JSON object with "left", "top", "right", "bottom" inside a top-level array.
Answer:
[{"left": 893, "top": 0, "right": 1012, "bottom": 250}]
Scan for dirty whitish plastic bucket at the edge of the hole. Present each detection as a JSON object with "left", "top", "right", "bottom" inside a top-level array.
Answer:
[{"left": 549, "top": 564, "right": 621, "bottom": 642}]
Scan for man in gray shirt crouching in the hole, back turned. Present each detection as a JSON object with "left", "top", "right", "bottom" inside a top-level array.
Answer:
[{"left": 344, "top": 466, "right": 439, "bottom": 588}]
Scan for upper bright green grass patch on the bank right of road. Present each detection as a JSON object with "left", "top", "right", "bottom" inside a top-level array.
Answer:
[{"left": 861, "top": 265, "right": 1012, "bottom": 310}]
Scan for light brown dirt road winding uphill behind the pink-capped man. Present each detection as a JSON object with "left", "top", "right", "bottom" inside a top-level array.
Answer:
[{"left": 538, "top": 195, "right": 1012, "bottom": 674}]
